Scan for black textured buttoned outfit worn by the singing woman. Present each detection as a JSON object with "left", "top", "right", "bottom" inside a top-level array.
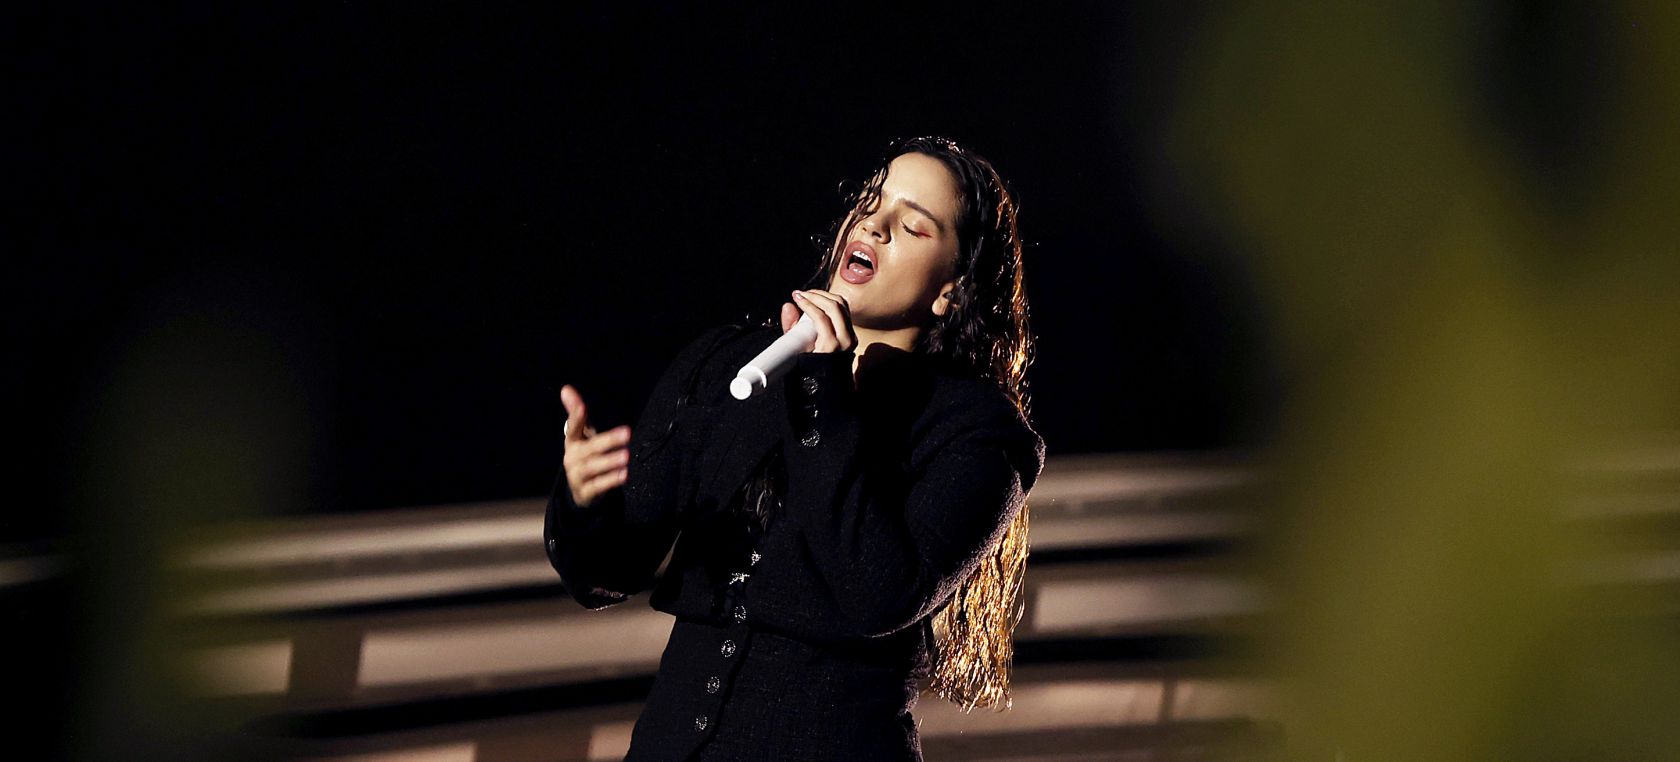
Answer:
[{"left": 544, "top": 326, "right": 1043, "bottom": 760}]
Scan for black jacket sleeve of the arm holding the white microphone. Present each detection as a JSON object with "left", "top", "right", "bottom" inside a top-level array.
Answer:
[{"left": 748, "top": 352, "right": 1043, "bottom": 641}]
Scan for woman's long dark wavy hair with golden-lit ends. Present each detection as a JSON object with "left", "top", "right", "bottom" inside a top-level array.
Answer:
[{"left": 810, "top": 138, "right": 1033, "bottom": 712}]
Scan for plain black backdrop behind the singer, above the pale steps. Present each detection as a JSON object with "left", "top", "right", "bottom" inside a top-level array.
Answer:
[{"left": 3, "top": 3, "right": 1275, "bottom": 540}]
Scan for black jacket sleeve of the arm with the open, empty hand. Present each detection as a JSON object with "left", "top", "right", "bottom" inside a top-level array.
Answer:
[{"left": 543, "top": 326, "right": 732, "bottom": 609}]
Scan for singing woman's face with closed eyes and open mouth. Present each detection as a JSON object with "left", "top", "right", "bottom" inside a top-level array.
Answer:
[{"left": 828, "top": 153, "right": 961, "bottom": 331}]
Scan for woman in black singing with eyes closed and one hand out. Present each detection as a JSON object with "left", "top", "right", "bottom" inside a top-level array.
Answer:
[{"left": 544, "top": 138, "right": 1043, "bottom": 760}]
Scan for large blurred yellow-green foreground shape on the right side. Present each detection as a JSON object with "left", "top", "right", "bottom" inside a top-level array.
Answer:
[{"left": 1161, "top": 3, "right": 1680, "bottom": 760}]
